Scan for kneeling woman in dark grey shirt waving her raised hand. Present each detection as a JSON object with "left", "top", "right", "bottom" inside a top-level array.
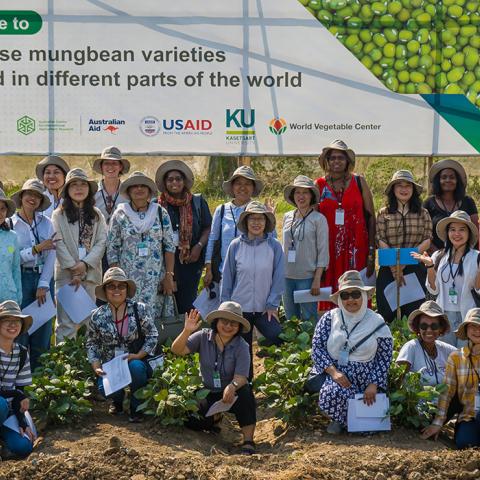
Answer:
[{"left": 172, "top": 302, "right": 257, "bottom": 454}]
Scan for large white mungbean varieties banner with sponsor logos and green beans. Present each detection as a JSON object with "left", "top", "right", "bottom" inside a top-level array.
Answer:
[{"left": 0, "top": 0, "right": 480, "bottom": 155}]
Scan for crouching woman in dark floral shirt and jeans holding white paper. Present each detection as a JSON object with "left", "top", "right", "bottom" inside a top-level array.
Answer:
[{"left": 86, "top": 267, "right": 158, "bottom": 422}]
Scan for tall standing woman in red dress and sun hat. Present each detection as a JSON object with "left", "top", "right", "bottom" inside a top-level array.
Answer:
[{"left": 316, "top": 140, "right": 375, "bottom": 311}]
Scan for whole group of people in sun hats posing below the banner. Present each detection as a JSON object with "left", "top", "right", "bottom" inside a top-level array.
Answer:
[{"left": 0, "top": 140, "right": 480, "bottom": 454}]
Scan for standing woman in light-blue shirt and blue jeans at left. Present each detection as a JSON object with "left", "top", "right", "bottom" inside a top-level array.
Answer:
[{"left": 12, "top": 178, "right": 58, "bottom": 370}]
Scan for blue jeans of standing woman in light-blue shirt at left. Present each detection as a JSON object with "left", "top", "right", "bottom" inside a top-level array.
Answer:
[{"left": 17, "top": 271, "right": 55, "bottom": 372}]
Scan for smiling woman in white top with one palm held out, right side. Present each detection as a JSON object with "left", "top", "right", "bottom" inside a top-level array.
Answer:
[{"left": 414, "top": 210, "right": 480, "bottom": 347}]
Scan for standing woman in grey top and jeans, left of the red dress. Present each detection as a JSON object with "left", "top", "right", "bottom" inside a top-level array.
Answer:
[{"left": 282, "top": 175, "right": 329, "bottom": 323}]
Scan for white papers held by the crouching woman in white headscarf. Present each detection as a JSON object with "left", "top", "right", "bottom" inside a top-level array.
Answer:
[{"left": 347, "top": 393, "right": 392, "bottom": 432}]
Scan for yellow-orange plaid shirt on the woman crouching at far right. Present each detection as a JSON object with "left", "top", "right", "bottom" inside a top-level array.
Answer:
[{"left": 433, "top": 347, "right": 480, "bottom": 426}]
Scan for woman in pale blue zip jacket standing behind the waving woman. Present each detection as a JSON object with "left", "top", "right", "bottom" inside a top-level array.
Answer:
[{"left": 220, "top": 201, "right": 285, "bottom": 378}]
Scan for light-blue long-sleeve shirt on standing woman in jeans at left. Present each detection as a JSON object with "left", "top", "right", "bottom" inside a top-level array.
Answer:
[{"left": 12, "top": 213, "right": 56, "bottom": 288}]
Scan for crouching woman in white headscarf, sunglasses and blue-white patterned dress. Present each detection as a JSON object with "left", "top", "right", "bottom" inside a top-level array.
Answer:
[{"left": 312, "top": 270, "right": 393, "bottom": 434}]
